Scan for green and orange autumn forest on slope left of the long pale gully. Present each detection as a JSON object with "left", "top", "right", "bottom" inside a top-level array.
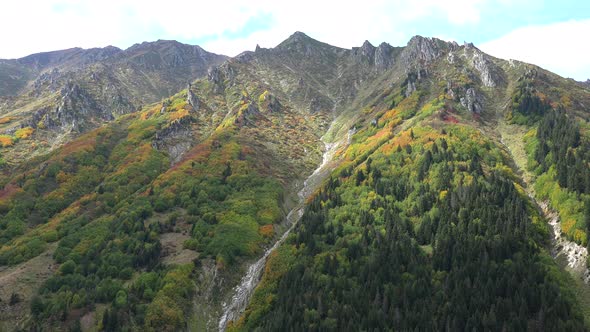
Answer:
[{"left": 0, "top": 97, "right": 283, "bottom": 331}]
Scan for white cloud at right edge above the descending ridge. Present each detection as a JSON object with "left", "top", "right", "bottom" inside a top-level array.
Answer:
[{"left": 479, "top": 19, "right": 590, "bottom": 81}]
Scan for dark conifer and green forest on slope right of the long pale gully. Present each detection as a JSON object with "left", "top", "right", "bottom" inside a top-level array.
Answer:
[{"left": 233, "top": 108, "right": 585, "bottom": 331}]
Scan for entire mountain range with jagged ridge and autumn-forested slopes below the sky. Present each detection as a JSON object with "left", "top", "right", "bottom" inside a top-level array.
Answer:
[{"left": 0, "top": 32, "right": 590, "bottom": 331}]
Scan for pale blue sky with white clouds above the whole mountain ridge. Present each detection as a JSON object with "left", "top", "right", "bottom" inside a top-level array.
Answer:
[{"left": 0, "top": 0, "right": 590, "bottom": 80}]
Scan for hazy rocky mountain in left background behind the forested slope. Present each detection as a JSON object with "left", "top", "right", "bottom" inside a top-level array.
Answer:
[{"left": 0, "top": 40, "right": 227, "bottom": 160}]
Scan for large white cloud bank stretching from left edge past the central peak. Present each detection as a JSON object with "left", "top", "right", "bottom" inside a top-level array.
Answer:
[{"left": 0, "top": 0, "right": 488, "bottom": 58}]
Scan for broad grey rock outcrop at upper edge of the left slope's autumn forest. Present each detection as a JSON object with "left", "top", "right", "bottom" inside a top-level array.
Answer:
[{"left": 152, "top": 116, "right": 195, "bottom": 165}]
